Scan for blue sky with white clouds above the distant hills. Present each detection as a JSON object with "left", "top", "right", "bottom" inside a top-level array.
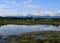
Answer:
[{"left": 0, "top": 0, "right": 60, "bottom": 16}]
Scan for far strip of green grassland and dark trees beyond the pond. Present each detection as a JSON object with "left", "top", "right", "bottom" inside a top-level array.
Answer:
[{"left": 0, "top": 17, "right": 60, "bottom": 25}]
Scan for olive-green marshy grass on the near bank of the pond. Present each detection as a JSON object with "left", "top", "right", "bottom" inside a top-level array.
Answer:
[{"left": 7, "top": 31, "right": 60, "bottom": 43}]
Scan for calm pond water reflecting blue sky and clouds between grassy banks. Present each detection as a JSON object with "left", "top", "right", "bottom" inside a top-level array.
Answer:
[{"left": 0, "top": 24, "right": 60, "bottom": 35}]
